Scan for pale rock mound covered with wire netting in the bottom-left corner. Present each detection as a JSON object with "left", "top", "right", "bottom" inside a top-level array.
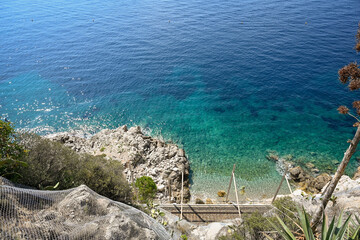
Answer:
[{"left": 0, "top": 177, "right": 171, "bottom": 240}]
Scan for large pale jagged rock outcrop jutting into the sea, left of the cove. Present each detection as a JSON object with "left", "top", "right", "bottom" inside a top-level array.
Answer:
[{"left": 47, "top": 126, "right": 190, "bottom": 203}]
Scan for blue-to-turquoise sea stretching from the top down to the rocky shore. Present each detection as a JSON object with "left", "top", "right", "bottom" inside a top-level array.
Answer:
[{"left": 0, "top": 0, "right": 360, "bottom": 197}]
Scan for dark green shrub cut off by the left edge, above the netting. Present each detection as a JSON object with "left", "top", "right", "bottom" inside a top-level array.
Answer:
[{"left": 0, "top": 120, "right": 26, "bottom": 181}]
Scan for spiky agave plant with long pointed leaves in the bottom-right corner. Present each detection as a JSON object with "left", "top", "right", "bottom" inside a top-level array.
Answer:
[{"left": 265, "top": 208, "right": 360, "bottom": 240}]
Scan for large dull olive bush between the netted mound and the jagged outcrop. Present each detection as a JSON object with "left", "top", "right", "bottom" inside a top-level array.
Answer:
[{"left": 18, "top": 134, "right": 131, "bottom": 202}]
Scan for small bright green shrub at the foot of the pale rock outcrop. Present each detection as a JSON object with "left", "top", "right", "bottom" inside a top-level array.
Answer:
[{"left": 135, "top": 176, "right": 157, "bottom": 203}]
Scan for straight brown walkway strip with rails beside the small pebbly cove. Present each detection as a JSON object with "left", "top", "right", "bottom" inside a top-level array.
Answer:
[{"left": 159, "top": 204, "right": 272, "bottom": 223}]
